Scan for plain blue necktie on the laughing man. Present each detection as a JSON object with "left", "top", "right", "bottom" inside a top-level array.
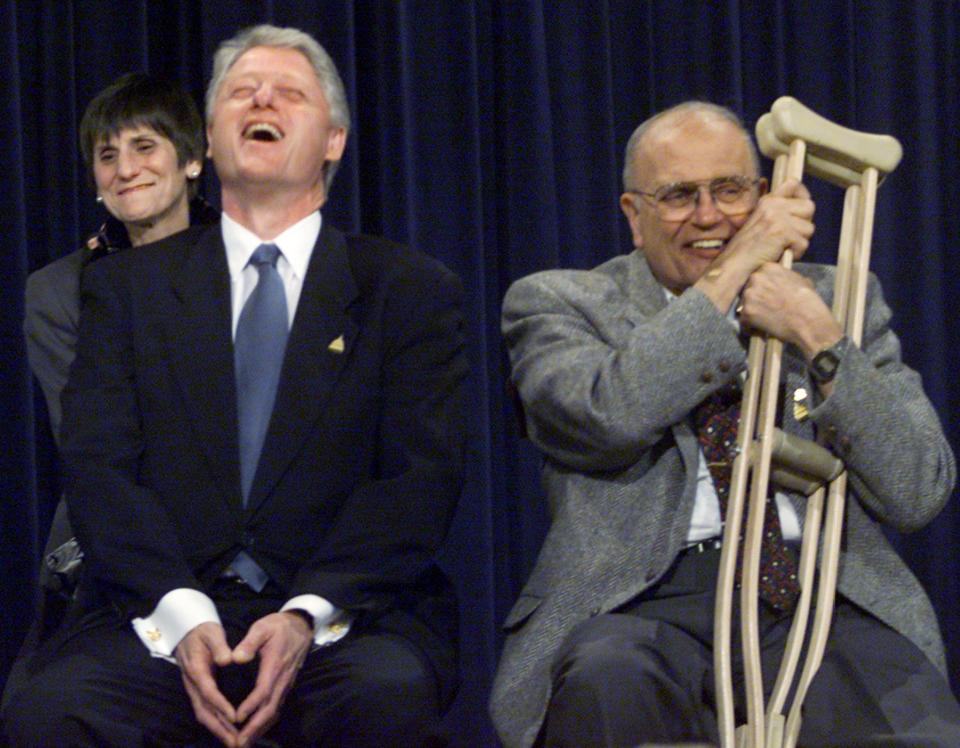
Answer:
[{"left": 233, "top": 244, "right": 288, "bottom": 505}]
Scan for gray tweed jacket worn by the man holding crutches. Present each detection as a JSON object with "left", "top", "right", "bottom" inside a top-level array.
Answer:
[{"left": 490, "top": 252, "right": 956, "bottom": 748}]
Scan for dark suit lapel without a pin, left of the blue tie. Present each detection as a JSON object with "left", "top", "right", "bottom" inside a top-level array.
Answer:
[{"left": 164, "top": 223, "right": 242, "bottom": 506}]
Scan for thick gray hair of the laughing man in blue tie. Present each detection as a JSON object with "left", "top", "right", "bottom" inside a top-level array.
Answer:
[{"left": 206, "top": 24, "right": 350, "bottom": 192}]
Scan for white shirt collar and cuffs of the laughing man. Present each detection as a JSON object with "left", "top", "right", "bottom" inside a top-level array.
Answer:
[{"left": 131, "top": 211, "right": 350, "bottom": 662}]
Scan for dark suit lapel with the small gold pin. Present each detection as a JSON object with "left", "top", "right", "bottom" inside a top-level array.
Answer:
[{"left": 248, "top": 222, "right": 359, "bottom": 510}]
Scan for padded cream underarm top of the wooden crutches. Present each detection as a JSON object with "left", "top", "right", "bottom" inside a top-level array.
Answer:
[{"left": 757, "top": 96, "right": 903, "bottom": 187}]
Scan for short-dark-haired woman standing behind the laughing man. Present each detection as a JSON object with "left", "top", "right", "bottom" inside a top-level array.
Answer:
[{"left": 24, "top": 73, "right": 219, "bottom": 608}]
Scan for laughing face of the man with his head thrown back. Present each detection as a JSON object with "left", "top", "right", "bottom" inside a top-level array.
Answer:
[{"left": 207, "top": 47, "right": 346, "bottom": 210}]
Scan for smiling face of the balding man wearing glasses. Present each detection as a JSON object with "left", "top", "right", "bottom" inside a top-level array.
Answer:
[{"left": 620, "top": 112, "right": 757, "bottom": 294}]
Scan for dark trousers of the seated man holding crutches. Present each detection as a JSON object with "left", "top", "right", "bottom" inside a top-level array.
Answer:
[{"left": 540, "top": 551, "right": 960, "bottom": 748}]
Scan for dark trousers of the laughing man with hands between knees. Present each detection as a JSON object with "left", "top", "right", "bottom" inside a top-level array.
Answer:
[{"left": 2, "top": 582, "right": 443, "bottom": 748}]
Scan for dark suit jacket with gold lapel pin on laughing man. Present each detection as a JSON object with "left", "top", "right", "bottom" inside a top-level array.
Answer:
[{"left": 62, "top": 223, "right": 467, "bottom": 700}]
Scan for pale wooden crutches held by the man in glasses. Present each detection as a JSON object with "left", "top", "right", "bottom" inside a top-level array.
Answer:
[{"left": 714, "top": 97, "right": 902, "bottom": 748}]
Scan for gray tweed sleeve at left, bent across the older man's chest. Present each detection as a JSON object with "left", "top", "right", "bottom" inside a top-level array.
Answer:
[{"left": 503, "top": 253, "right": 745, "bottom": 471}]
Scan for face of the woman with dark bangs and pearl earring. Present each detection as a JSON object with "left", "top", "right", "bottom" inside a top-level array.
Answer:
[{"left": 93, "top": 125, "right": 201, "bottom": 243}]
